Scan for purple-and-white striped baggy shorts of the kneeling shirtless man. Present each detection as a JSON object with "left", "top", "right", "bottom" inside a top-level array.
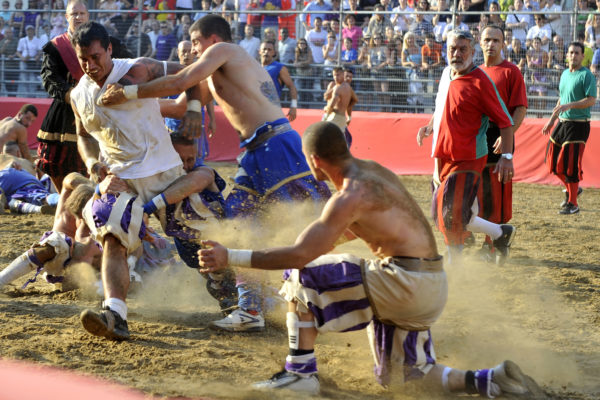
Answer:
[{"left": 280, "top": 254, "right": 447, "bottom": 385}]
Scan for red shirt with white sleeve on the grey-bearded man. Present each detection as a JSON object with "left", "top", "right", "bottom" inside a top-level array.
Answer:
[{"left": 433, "top": 67, "right": 513, "bottom": 161}]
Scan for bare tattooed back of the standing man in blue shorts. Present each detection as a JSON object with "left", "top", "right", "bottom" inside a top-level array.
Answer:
[{"left": 199, "top": 43, "right": 284, "bottom": 138}]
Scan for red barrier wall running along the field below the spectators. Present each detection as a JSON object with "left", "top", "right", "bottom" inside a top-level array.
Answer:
[{"left": 0, "top": 98, "right": 600, "bottom": 187}]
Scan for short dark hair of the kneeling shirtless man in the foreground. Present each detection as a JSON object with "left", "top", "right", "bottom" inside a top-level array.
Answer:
[{"left": 302, "top": 121, "right": 351, "bottom": 161}]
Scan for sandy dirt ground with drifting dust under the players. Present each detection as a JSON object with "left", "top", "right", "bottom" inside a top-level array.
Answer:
[{"left": 0, "top": 165, "right": 600, "bottom": 400}]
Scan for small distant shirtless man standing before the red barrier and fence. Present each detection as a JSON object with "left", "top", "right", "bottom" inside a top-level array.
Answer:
[{"left": 323, "top": 67, "right": 358, "bottom": 147}]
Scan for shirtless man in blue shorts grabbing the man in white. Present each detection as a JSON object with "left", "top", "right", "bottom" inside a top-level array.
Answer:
[{"left": 102, "top": 15, "right": 330, "bottom": 216}]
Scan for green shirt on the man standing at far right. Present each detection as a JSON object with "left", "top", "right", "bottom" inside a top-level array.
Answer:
[{"left": 558, "top": 67, "right": 596, "bottom": 120}]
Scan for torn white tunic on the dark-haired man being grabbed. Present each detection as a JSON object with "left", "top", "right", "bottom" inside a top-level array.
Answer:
[{"left": 71, "top": 59, "right": 182, "bottom": 179}]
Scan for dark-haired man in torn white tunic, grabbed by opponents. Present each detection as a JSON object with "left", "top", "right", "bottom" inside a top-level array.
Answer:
[{"left": 70, "top": 22, "right": 241, "bottom": 339}]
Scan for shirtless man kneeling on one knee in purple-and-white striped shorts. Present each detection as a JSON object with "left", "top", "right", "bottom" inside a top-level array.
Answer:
[{"left": 200, "top": 122, "right": 536, "bottom": 397}]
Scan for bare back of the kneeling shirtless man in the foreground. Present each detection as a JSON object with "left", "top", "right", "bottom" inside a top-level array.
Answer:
[{"left": 339, "top": 160, "right": 438, "bottom": 258}]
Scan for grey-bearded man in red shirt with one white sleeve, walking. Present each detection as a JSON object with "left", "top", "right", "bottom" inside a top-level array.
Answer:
[{"left": 417, "top": 30, "right": 515, "bottom": 263}]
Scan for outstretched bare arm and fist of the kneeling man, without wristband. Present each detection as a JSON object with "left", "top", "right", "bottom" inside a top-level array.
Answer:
[{"left": 199, "top": 192, "right": 360, "bottom": 272}]
